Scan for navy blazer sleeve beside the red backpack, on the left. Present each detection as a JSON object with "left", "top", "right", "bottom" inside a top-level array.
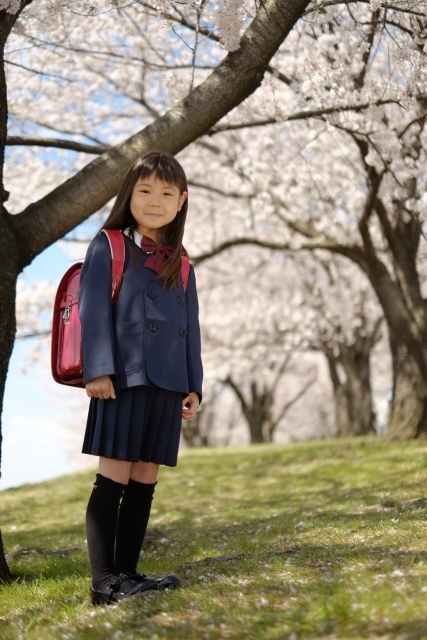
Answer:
[{"left": 78, "top": 234, "right": 116, "bottom": 384}]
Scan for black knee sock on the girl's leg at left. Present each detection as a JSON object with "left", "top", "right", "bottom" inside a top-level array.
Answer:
[{"left": 86, "top": 473, "right": 126, "bottom": 590}]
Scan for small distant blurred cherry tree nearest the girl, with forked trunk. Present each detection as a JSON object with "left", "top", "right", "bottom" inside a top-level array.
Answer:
[{"left": 196, "top": 248, "right": 317, "bottom": 443}]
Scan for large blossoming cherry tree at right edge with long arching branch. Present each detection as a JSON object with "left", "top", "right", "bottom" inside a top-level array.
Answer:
[{"left": 191, "top": 2, "right": 427, "bottom": 439}]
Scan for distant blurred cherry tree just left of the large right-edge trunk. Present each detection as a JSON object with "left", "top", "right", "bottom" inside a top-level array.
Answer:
[{"left": 295, "top": 251, "right": 383, "bottom": 437}]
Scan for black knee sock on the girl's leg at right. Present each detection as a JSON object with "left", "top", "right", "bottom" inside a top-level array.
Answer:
[{"left": 115, "top": 480, "right": 156, "bottom": 573}]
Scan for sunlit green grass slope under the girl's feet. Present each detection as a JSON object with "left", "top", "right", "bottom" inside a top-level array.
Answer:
[{"left": 0, "top": 439, "right": 427, "bottom": 640}]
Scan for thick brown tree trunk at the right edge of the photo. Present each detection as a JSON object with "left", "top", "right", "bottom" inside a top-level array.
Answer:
[{"left": 358, "top": 120, "right": 427, "bottom": 440}]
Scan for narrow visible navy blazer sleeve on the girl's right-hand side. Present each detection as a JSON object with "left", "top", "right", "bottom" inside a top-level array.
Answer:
[{"left": 186, "top": 266, "right": 203, "bottom": 402}]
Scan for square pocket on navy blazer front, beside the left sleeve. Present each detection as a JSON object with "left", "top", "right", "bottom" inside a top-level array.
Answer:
[{"left": 114, "top": 322, "right": 144, "bottom": 375}]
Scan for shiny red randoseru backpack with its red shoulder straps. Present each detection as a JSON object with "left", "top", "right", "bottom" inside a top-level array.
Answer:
[{"left": 51, "top": 229, "right": 190, "bottom": 388}]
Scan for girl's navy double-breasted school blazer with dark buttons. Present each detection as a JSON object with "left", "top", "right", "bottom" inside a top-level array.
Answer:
[{"left": 78, "top": 234, "right": 203, "bottom": 400}]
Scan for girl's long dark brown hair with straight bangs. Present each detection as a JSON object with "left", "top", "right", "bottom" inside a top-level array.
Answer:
[{"left": 101, "top": 151, "right": 188, "bottom": 288}]
